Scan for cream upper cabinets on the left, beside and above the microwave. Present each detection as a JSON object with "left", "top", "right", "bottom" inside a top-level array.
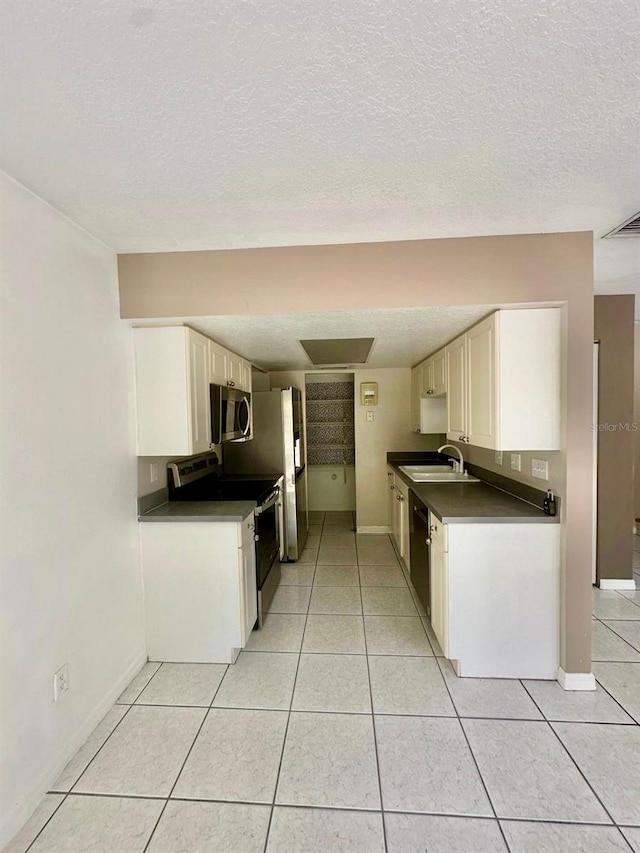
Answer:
[{"left": 133, "top": 326, "right": 251, "bottom": 456}]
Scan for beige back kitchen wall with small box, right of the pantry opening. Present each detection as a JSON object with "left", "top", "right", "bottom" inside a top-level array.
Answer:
[{"left": 355, "top": 367, "right": 444, "bottom": 529}]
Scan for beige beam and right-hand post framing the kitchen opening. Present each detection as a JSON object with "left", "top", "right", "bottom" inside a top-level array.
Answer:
[{"left": 118, "top": 232, "right": 593, "bottom": 672}]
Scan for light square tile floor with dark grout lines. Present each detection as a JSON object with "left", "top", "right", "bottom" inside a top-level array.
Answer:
[{"left": 7, "top": 513, "right": 640, "bottom": 853}]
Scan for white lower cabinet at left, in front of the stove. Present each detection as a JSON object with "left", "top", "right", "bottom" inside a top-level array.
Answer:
[{"left": 139, "top": 513, "right": 258, "bottom": 663}]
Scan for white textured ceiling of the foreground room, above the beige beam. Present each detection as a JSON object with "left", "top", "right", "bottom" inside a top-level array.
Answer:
[{"left": 2, "top": 0, "right": 640, "bottom": 312}]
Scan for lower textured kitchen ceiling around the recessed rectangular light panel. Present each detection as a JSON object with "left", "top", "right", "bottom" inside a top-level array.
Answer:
[{"left": 131, "top": 305, "right": 513, "bottom": 370}]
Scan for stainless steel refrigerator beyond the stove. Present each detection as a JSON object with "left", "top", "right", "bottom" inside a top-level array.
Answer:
[{"left": 223, "top": 388, "right": 309, "bottom": 560}]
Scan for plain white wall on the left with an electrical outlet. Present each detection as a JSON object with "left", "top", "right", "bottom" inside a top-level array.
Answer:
[{"left": 0, "top": 175, "right": 146, "bottom": 846}]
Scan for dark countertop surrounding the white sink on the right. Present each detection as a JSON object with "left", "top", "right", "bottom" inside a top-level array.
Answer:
[{"left": 387, "top": 454, "right": 560, "bottom": 524}]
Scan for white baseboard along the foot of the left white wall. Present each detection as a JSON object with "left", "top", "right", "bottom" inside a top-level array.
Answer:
[{"left": 0, "top": 648, "right": 147, "bottom": 850}]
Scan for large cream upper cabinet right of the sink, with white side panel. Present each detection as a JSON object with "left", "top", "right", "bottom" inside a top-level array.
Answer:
[{"left": 445, "top": 308, "right": 561, "bottom": 450}]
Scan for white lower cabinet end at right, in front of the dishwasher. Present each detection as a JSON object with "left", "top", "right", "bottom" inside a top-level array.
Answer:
[{"left": 430, "top": 515, "right": 560, "bottom": 679}]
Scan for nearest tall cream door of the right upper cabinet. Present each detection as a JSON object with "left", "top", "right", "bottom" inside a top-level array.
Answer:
[{"left": 465, "top": 316, "right": 498, "bottom": 448}]
